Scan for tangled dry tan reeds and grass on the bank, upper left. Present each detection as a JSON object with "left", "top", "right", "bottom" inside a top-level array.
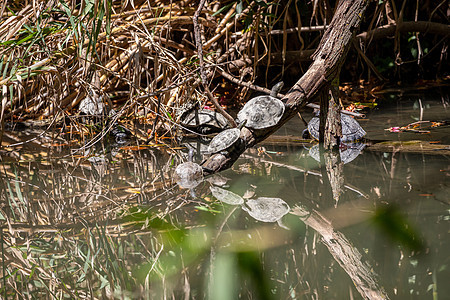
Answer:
[{"left": 0, "top": 1, "right": 334, "bottom": 145}]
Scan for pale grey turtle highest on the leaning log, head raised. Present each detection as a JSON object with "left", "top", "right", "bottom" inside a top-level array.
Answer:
[{"left": 236, "top": 82, "right": 284, "bottom": 129}]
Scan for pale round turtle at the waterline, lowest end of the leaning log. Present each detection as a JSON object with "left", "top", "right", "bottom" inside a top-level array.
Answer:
[{"left": 174, "top": 149, "right": 203, "bottom": 189}]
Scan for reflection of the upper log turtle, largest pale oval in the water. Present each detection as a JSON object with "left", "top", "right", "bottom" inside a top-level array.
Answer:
[{"left": 242, "top": 197, "right": 290, "bottom": 229}]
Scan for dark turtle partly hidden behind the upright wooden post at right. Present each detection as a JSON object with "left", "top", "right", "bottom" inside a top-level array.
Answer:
[{"left": 308, "top": 113, "right": 366, "bottom": 142}]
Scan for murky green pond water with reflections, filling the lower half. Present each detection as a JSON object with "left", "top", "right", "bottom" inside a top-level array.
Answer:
[{"left": 0, "top": 91, "right": 450, "bottom": 299}]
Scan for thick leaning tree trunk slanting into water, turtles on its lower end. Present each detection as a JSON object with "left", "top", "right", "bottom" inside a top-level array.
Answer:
[{"left": 202, "top": 0, "right": 368, "bottom": 173}]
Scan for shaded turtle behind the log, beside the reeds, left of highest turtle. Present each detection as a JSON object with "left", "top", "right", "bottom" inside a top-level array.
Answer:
[{"left": 180, "top": 109, "right": 230, "bottom": 134}]
